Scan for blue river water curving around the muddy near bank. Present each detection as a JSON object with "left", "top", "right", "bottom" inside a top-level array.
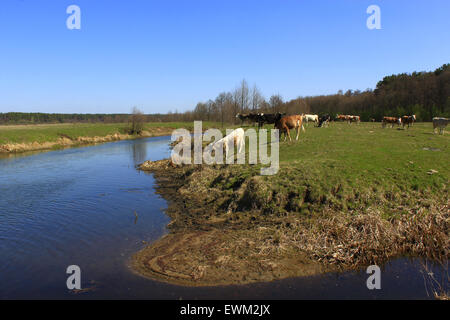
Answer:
[{"left": 0, "top": 137, "right": 445, "bottom": 299}]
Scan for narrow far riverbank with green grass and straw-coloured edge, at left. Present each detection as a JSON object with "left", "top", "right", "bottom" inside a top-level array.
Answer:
[{"left": 0, "top": 122, "right": 218, "bottom": 153}]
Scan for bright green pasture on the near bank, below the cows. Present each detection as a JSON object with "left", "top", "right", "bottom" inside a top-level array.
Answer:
[{"left": 280, "top": 123, "right": 450, "bottom": 215}]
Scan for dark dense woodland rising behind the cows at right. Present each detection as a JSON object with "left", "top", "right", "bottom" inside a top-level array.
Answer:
[{"left": 300, "top": 64, "right": 450, "bottom": 121}]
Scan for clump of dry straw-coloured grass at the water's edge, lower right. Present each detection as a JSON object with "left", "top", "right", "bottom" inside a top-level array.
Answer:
[{"left": 293, "top": 205, "right": 450, "bottom": 268}]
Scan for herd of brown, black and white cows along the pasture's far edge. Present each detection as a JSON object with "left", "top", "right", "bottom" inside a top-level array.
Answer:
[{"left": 236, "top": 112, "right": 450, "bottom": 140}]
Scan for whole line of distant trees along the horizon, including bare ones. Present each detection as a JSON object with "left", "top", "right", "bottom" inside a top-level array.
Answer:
[{"left": 0, "top": 64, "right": 450, "bottom": 124}]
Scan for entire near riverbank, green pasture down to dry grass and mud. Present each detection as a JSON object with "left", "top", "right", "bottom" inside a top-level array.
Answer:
[{"left": 133, "top": 123, "right": 450, "bottom": 286}]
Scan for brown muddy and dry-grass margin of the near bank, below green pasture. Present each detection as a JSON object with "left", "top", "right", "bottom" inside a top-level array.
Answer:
[{"left": 131, "top": 160, "right": 450, "bottom": 286}]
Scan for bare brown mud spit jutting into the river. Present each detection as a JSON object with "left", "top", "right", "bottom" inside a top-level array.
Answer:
[{"left": 131, "top": 160, "right": 330, "bottom": 286}]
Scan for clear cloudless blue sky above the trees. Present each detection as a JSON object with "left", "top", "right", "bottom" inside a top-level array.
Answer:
[{"left": 0, "top": 0, "right": 450, "bottom": 113}]
